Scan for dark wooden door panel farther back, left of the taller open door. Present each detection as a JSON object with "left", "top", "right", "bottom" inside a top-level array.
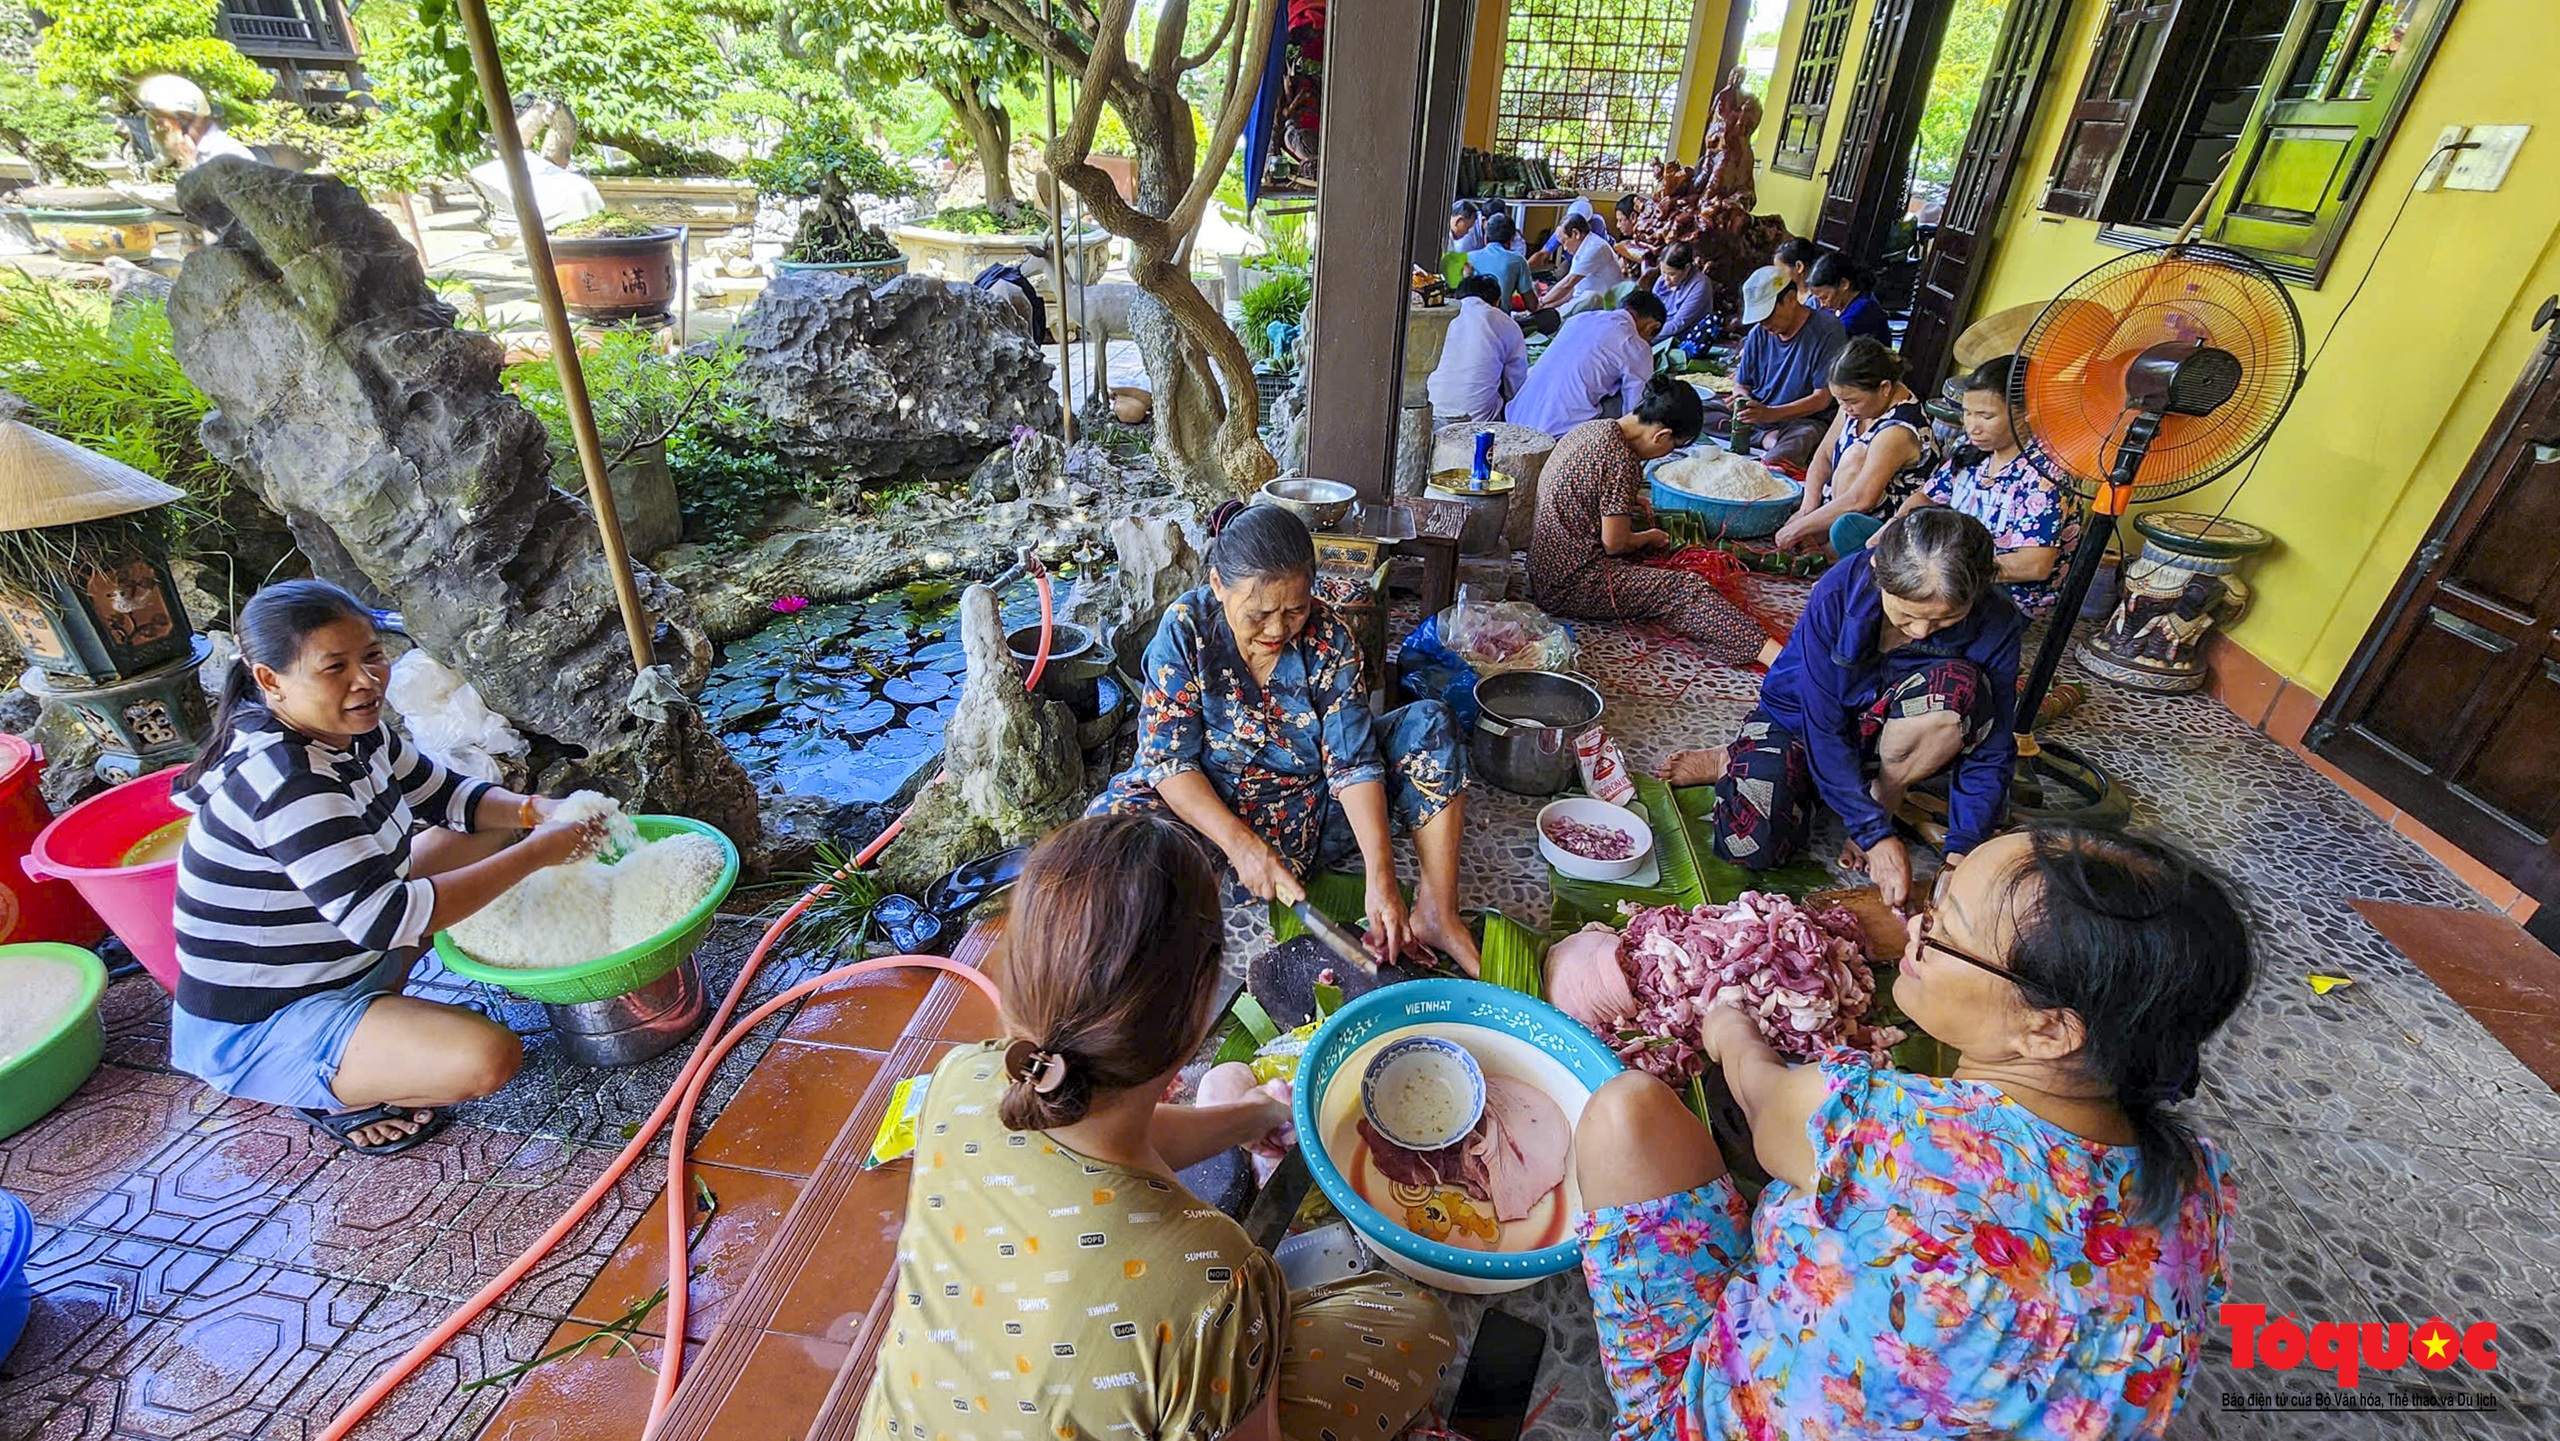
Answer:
[{"left": 1812, "top": 0, "right": 1951, "bottom": 264}]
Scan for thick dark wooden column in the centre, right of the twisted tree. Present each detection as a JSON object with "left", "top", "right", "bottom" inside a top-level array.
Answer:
[{"left": 1306, "top": 0, "right": 1464, "bottom": 499}]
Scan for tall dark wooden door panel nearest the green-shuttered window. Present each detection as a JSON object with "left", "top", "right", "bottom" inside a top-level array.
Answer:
[{"left": 1902, "top": 0, "right": 2071, "bottom": 394}]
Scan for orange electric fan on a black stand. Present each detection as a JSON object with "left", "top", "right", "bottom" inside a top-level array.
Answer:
[{"left": 2010, "top": 243, "right": 2301, "bottom": 811}]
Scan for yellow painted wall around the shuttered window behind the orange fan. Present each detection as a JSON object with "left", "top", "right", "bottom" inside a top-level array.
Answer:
[{"left": 1955, "top": 0, "right": 2560, "bottom": 691}]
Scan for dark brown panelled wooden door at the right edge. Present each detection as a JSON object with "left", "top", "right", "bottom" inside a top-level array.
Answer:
[{"left": 2309, "top": 297, "right": 2560, "bottom": 944}]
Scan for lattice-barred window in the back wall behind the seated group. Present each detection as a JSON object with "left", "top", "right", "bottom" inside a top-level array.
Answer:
[{"left": 1495, "top": 0, "right": 1695, "bottom": 189}]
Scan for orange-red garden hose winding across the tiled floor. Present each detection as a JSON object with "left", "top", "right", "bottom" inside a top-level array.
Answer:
[{"left": 320, "top": 561, "right": 1055, "bottom": 1441}]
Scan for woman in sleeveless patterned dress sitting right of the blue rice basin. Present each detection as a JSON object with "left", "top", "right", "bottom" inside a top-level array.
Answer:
[{"left": 1774, "top": 338, "right": 1938, "bottom": 555}]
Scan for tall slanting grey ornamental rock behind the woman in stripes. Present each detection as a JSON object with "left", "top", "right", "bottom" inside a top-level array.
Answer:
[{"left": 169, "top": 159, "right": 758, "bottom": 847}]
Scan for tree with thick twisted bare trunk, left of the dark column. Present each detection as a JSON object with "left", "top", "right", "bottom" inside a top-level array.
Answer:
[{"left": 947, "top": 0, "right": 1280, "bottom": 504}]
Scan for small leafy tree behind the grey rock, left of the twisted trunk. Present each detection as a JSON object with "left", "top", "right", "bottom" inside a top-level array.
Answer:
[{"left": 781, "top": 0, "right": 1039, "bottom": 215}]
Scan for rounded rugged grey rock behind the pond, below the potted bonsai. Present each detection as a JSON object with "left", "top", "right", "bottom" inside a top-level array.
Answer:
[{"left": 735, "top": 271, "right": 1060, "bottom": 488}]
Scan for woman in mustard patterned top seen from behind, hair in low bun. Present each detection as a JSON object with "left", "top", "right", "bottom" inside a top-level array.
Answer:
[{"left": 855, "top": 816, "right": 1457, "bottom": 1441}]
